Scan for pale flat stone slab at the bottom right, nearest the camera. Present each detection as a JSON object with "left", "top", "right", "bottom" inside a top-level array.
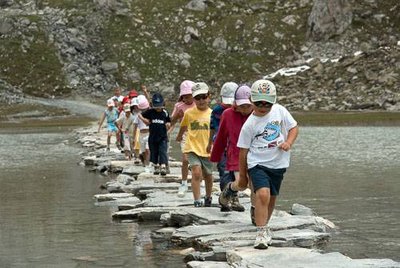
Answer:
[{"left": 225, "top": 247, "right": 400, "bottom": 268}]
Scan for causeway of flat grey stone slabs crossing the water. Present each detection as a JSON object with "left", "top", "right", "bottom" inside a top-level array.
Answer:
[{"left": 76, "top": 126, "right": 400, "bottom": 267}]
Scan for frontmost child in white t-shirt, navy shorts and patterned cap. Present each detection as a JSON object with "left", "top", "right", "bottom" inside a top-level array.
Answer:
[{"left": 220, "top": 80, "right": 298, "bottom": 249}]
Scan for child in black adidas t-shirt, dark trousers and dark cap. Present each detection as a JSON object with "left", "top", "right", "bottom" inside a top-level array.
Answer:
[{"left": 139, "top": 93, "right": 171, "bottom": 176}]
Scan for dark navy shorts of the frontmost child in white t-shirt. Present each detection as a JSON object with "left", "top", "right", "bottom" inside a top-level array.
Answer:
[{"left": 249, "top": 165, "right": 286, "bottom": 195}]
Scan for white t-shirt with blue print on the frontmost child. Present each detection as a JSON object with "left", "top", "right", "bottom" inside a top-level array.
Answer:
[{"left": 237, "top": 104, "right": 297, "bottom": 169}]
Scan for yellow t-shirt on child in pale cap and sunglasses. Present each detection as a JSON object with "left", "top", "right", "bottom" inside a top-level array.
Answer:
[{"left": 181, "top": 107, "right": 212, "bottom": 157}]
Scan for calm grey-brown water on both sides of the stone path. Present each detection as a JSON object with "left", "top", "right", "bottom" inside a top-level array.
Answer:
[{"left": 0, "top": 127, "right": 400, "bottom": 268}]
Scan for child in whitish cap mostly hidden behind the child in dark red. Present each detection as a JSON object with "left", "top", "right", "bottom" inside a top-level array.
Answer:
[{"left": 207, "top": 82, "right": 238, "bottom": 185}]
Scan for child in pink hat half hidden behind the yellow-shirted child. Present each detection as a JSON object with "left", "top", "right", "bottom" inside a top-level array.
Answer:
[{"left": 169, "top": 80, "right": 195, "bottom": 197}]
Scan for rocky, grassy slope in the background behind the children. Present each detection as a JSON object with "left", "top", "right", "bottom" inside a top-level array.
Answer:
[{"left": 0, "top": 0, "right": 400, "bottom": 111}]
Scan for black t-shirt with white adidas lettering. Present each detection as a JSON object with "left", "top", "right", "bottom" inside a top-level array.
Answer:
[{"left": 142, "top": 109, "right": 171, "bottom": 142}]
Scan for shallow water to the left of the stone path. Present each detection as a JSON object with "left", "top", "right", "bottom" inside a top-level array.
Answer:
[{"left": 0, "top": 131, "right": 185, "bottom": 268}]
